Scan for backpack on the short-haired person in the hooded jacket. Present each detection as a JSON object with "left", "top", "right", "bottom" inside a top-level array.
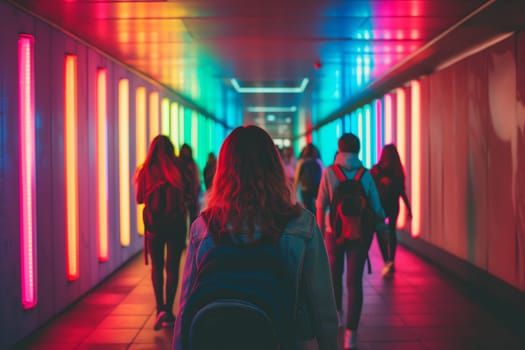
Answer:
[{"left": 330, "top": 165, "right": 371, "bottom": 244}]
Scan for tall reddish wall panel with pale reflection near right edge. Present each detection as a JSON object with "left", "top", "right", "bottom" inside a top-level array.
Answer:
[{"left": 487, "top": 40, "right": 523, "bottom": 283}]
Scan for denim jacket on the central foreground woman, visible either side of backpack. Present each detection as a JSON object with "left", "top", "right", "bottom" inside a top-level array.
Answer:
[{"left": 173, "top": 209, "right": 337, "bottom": 350}]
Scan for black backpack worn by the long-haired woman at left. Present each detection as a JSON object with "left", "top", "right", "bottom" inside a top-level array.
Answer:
[{"left": 142, "top": 181, "right": 186, "bottom": 236}]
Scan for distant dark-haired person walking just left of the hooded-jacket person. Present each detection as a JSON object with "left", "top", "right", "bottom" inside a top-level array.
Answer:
[{"left": 294, "top": 143, "right": 322, "bottom": 213}]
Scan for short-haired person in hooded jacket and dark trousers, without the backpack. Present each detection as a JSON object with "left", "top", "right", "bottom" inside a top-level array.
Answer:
[{"left": 316, "top": 134, "right": 385, "bottom": 349}]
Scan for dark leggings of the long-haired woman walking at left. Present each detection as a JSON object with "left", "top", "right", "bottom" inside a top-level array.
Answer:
[{"left": 147, "top": 237, "right": 185, "bottom": 313}]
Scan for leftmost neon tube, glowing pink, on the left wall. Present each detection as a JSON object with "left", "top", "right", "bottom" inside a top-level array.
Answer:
[{"left": 18, "top": 34, "right": 37, "bottom": 309}]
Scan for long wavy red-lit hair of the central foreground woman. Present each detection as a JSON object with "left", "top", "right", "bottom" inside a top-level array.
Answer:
[{"left": 203, "top": 125, "right": 301, "bottom": 240}]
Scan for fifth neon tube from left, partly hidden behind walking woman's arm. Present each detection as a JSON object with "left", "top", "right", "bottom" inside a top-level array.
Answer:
[{"left": 135, "top": 86, "right": 148, "bottom": 234}]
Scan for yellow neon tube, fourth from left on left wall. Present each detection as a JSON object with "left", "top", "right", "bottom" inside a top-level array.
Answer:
[{"left": 118, "top": 79, "right": 131, "bottom": 247}]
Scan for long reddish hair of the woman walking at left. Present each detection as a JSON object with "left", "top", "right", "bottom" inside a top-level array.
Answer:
[{"left": 135, "top": 135, "right": 183, "bottom": 190}]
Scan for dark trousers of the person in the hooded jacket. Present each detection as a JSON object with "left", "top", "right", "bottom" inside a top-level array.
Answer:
[{"left": 325, "top": 233, "right": 371, "bottom": 330}]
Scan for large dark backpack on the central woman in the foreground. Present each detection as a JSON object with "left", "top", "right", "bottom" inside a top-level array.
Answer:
[{"left": 181, "top": 242, "right": 295, "bottom": 349}]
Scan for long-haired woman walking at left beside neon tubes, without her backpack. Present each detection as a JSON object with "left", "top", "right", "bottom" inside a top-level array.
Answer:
[{"left": 135, "top": 135, "right": 186, "bottom": 330}]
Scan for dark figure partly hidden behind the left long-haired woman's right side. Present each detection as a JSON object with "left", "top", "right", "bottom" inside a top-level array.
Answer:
[{"left": 179, "top": 143, "right": 201, "bottom": 223}]
